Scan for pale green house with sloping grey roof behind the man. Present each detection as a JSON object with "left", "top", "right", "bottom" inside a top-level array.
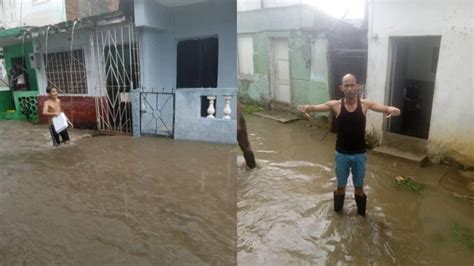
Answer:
[{"left": 238, "top": 4, "right": 366, "bottom": 118}]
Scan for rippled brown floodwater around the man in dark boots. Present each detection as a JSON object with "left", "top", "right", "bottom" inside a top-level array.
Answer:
[{"left": 237, "top": 116, "right": 474, "bottom": 265}]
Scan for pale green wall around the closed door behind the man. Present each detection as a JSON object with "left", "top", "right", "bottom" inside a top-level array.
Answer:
[{"left": 238, "top": 31, "right": 330, "bottom": 115}]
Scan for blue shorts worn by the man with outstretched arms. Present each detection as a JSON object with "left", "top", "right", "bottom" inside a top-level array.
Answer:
[{"left": 336, "top": 151, "right": 367, "bottom": 187}]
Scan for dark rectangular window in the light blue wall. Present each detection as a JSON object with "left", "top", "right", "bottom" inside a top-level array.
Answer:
[{"left": 176, "top": 37, "right": 219, "bottom": 89}]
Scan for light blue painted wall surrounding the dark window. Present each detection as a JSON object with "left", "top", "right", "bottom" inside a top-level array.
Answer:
[{"left": 134, "top": 0, "right": 237, "bottom": 143}]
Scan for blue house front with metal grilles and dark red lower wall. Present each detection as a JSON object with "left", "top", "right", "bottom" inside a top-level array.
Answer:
[{"left": 0, "top": 0, "right": 237, "bottom": 143}]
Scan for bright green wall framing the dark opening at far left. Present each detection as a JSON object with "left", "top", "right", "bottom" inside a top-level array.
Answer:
[{"left": 3, "top": 42, "right": 38, "bottom": 91}]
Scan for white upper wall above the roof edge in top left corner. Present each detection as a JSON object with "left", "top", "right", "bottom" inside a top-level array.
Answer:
[{"left": 0, "top": 0, "right": 66, "bottom": 29}]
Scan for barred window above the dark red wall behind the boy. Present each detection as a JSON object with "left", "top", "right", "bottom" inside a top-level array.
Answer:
[{"left": 45, "top": 50, "right": 87, "bottom": 94}]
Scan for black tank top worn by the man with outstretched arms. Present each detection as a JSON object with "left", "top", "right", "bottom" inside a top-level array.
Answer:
[{"left": 336, "top": 98, "right": 366, "bottom": 154}]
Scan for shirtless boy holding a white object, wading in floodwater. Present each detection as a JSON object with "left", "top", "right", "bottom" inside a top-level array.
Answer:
[{"left": 43, "top": 87, "right": 73, "bottom": 147}]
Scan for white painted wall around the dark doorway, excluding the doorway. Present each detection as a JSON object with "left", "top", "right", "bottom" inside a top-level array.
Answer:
[{"left": 367, "top": 0, "right": 474, "bottom": 158}]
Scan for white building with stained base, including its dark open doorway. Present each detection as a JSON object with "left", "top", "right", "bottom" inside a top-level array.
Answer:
[{"left": 367, "top": 0, "right": 474, "bottom": 165}]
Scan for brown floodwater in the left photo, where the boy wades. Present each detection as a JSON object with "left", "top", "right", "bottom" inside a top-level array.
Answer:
[{"left": 0, "top": 122, "right": 236, "bottom": 265}]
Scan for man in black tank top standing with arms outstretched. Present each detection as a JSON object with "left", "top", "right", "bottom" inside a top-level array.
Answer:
[{"left": 298, "top": 74, "right": 400, "bottom": 216}]
